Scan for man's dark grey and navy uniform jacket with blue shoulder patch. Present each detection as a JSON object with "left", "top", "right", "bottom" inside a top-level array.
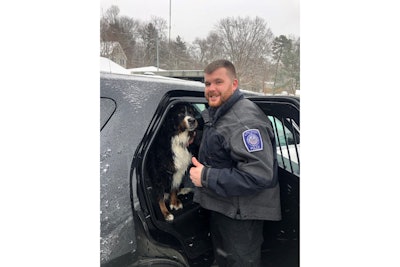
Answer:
[{"left": 194, "top": 89, "right": 281, "bottom": 221}]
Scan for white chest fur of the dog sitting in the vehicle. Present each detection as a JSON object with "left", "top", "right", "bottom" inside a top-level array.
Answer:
[{"left": 171, "top": 131, "right": 192, "bottom": 188}]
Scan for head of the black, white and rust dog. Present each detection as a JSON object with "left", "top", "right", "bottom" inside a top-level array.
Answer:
[{"left": 169, "top": 103, "right": 198, "bottom": 132}]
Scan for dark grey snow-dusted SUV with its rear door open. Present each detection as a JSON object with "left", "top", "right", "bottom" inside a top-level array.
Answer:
[{"left": 100, "top": 73, "right": 300, "bottom": 266}]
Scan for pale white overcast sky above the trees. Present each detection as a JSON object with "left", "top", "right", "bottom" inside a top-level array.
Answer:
[{"left": 100, "top": 0, "right": 300, "bottom": 43}]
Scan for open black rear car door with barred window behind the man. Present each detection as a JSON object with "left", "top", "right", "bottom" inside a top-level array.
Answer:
[{"left": 248, "top": 96, "right": 300, "bottom": 267}]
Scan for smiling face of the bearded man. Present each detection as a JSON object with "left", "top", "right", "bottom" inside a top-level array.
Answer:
[{"left": 204, "top": 68, "right": 238, "bottom": 108}]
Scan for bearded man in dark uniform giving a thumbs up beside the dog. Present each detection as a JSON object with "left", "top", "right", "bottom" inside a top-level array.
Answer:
[{"left": 190, "top": 60, "right": 281, "bottom": 267}]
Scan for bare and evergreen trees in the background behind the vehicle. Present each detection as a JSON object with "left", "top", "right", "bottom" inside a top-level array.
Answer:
[{"left": 100, "top": 6, "right": 300, "bottom": 93}]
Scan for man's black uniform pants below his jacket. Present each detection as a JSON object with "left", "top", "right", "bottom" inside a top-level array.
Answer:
[{"left": 210, "top": 211, "right": 264, "bottom": 267}]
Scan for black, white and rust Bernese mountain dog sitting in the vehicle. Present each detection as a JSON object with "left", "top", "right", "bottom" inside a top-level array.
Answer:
[{"left": 148, "top": 102, "right": 198, "bottom": 222}]
